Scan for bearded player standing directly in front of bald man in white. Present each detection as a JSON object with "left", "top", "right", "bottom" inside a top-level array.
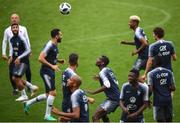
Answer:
[{"left": 8, "top": 23, "right": 38, "bottom": 101}]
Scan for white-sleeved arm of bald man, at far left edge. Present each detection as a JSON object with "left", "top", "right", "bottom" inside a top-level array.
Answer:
[{"left": 2, "top": 30, "right": 8, "bottom": 60}]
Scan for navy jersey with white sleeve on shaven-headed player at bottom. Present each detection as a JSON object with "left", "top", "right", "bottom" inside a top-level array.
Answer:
[{"left": 71, "top": 89, "right": 89, "bottom": 122}]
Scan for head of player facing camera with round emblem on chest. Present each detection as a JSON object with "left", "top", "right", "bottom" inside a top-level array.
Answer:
[{"left": 128, "top": 69, "right": 139, "bottom": 83}]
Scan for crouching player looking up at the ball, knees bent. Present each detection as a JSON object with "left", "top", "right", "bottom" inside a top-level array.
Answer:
[{"left": 87, "top": 55, "right": 120, "bottom": 122}]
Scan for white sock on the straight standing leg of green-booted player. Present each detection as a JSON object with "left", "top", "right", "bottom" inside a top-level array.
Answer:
[{"left": 45, "top": 95, "right": 55, "bottom": 117}]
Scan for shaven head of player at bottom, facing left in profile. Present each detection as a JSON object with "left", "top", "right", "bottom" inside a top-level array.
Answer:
[{"left": 67, "top": 75, "right": 82, "bottom": 89}]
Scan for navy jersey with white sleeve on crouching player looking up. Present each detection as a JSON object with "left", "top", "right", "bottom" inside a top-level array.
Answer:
[{"left": 99, "top": 67, "right": 120, "bottom": 101}]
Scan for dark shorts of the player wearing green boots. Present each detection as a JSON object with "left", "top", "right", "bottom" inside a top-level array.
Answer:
[{"left": 40, "top": 68, "right": 56, "bottom": 93}]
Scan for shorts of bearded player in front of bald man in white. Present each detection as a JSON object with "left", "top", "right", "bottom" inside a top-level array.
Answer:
[{"left": 12, "top": 63, "right": 27, "bottom": 77}]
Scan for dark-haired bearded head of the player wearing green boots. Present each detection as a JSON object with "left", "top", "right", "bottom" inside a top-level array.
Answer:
[{"left": 51, "top": 28, "right": 62, "bottom": 43}]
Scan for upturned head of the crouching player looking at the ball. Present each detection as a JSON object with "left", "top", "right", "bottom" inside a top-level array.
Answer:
[{"left": 96, "top": 55, "right": 109, "bottom": 67}]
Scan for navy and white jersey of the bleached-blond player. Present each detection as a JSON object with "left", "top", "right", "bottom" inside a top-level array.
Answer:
[{"left": 134, "top": 27, "right": 149, "bottom": 59}]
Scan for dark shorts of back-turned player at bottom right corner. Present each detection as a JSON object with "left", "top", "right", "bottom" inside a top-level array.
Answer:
[{"left": 154, "top": 105, "right": 173, "bottom": 122}]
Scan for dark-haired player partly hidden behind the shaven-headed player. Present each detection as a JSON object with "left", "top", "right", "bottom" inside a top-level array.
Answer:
[{"left": 62, "top": 53, "right": 78, "bottom": 112}]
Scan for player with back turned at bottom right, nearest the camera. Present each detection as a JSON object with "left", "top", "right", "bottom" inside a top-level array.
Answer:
[{"left": 147, "top": 59, "right": 175, "bottom": 122}]
